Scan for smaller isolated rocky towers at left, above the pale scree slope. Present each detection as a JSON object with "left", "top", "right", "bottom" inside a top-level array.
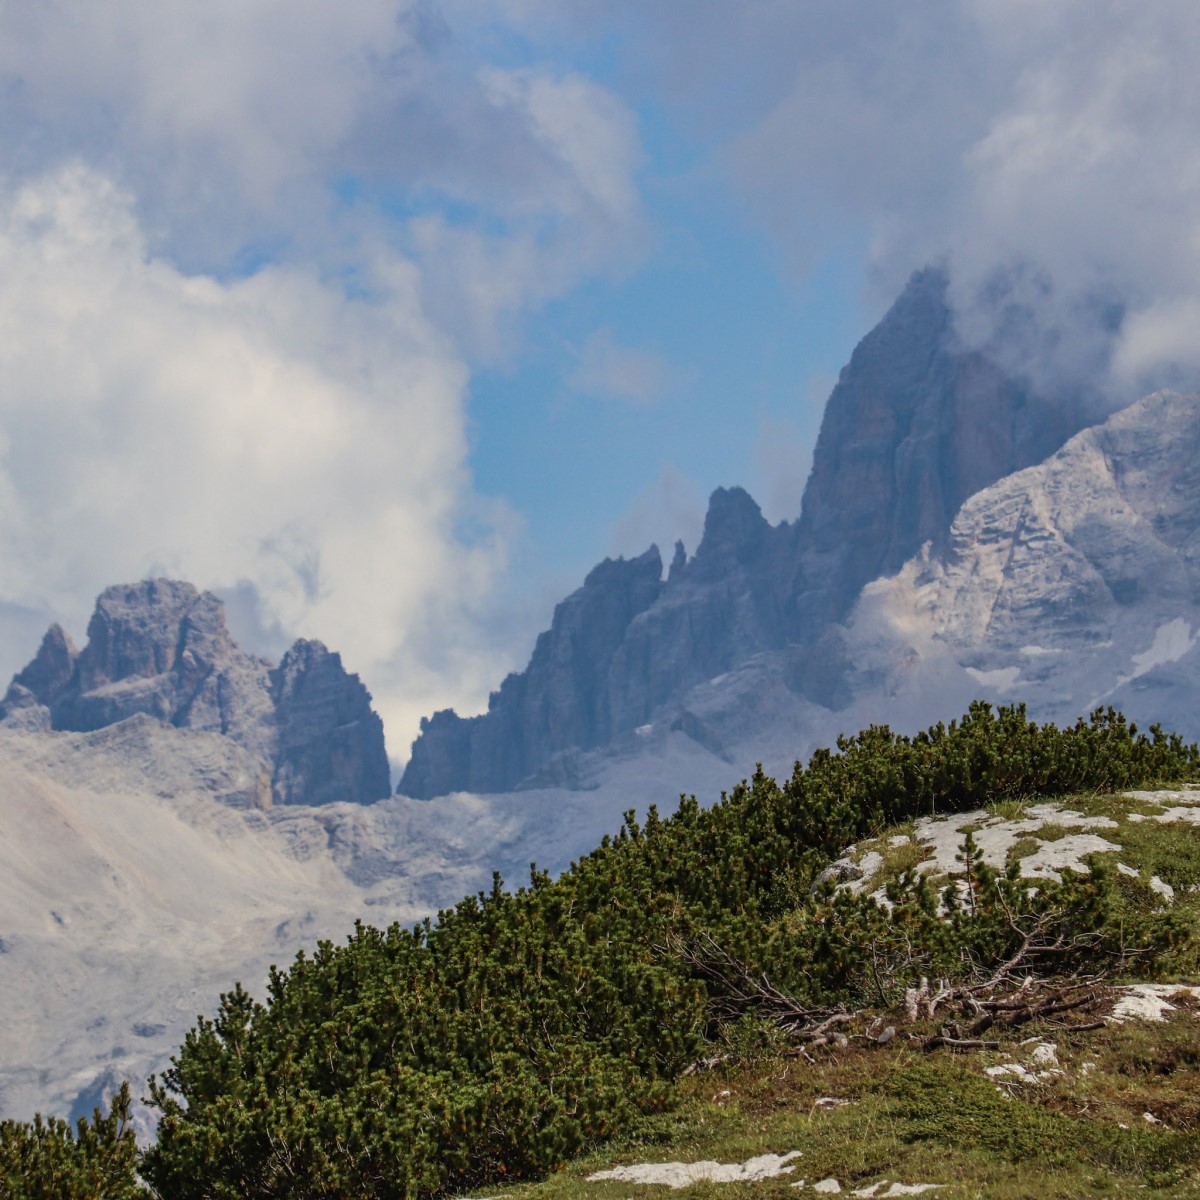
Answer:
[{"left": 0, "top": 580, "right": 390, "bottom": 804}]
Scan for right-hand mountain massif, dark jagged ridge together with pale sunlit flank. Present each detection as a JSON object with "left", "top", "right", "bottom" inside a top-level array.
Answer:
[{"left": 400, "top": 270, "right": 1200, "bottom": 798}]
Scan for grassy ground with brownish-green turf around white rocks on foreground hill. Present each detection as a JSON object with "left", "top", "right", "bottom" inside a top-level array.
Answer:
[{"left": 470, "top": 796, "right": 1200, "bottom": 1200}]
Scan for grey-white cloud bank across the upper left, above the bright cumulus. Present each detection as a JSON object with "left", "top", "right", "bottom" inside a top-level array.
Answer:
[{"left": 0, "top": 0, "right": 642, "bottom": 359}]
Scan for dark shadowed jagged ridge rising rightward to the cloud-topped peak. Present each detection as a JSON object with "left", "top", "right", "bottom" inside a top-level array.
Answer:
[{"left": 400, "top": 270, "right": 1086, "bottom": 798}]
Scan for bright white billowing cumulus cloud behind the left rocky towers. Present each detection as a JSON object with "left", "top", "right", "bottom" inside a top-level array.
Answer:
[{"left": 0, "top": 164, "right": 511, "bottom": 756}]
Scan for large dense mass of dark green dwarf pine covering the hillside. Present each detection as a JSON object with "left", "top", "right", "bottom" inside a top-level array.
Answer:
[{"left": 143, "top": 703, "right": 1200, "bottom": 1200}]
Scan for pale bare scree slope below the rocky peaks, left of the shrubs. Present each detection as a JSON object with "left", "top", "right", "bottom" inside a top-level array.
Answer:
[{"left": 0, "top": 700, "right": 726, "bottom": 1133}]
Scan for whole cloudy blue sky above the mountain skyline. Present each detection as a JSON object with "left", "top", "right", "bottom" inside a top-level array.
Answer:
[{"left": 0, "top": 0, "right": 1200, "bottom": 761}]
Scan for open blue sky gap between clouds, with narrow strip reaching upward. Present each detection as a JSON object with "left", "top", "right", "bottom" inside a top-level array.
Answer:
[{"left": 436, "top": 14, "right": 878, "bottom": 576}]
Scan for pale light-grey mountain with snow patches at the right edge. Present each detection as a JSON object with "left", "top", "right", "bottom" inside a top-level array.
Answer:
[{"left": 856, "top": 391, "right": 1200, "bottom": 737}]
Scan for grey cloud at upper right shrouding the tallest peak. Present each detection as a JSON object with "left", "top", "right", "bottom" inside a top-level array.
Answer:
[{"left": 580, "top": 0, "right": 1200, "bottom": 401}]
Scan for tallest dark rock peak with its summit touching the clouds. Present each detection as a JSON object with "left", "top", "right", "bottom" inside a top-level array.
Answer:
[{"left": 784, "top": 270, "right": 1086, "bottom": 641}]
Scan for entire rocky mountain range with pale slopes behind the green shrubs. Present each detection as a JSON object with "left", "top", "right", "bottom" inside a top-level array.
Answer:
[{"left": 0, "top": 270, "right": 1200, "bottom": 1115}]
